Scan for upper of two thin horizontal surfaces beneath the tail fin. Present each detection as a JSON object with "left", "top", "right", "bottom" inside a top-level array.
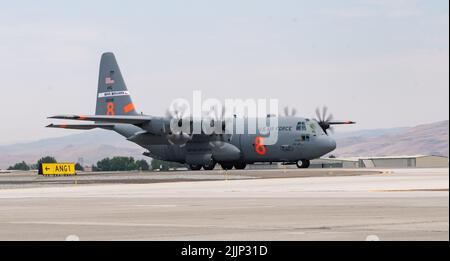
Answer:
[{"left": 48, "top": 115, "right": 151, "bottom": 125}]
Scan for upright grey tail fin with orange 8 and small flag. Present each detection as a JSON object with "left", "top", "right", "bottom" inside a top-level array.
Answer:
[{"left": 95, "top": 53, "right": 137, "bottom": 115}]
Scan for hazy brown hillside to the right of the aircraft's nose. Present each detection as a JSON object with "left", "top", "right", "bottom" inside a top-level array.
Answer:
[{"left": 332, "top": 121, "right": 449, "bottom": 157}]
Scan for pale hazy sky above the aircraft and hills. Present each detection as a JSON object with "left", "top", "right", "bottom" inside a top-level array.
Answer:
[{"left": 0, "top": 0, "right": 449, "bottom": 143}]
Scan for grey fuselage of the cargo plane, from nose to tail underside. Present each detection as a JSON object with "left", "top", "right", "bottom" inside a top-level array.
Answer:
[{"left": 110, "top": 117, "right": 336, "bottom": 165}]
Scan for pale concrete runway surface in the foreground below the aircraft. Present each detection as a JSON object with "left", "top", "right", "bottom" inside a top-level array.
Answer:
[{"left": 0, "top": 168, "right": 449, "bottom": 240}]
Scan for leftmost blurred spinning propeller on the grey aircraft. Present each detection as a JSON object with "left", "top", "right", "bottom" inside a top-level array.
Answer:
[{"left": 166, "top": 103, "right": 193, "bottom": 145}]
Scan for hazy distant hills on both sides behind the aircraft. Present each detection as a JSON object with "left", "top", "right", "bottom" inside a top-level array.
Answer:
[{"left": 0, "top": 121, "right": 449, "bottom": 169}]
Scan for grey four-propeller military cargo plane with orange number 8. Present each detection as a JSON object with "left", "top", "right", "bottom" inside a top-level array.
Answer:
[{"left": 47, "top": 53, "right": 355, "bottom": 170}]
